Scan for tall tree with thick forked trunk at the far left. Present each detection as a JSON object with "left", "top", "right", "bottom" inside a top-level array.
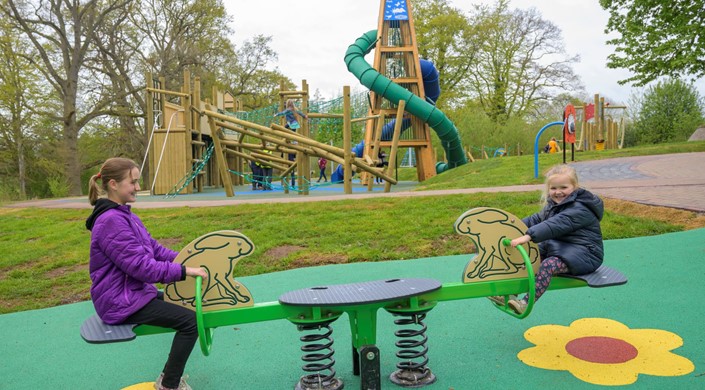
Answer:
[{"left": 2, "top": 0, "right": 130, "bottom": 195}]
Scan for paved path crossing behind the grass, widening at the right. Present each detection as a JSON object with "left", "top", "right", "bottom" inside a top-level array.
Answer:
[{"left": 5, "top": 152, "right": 705, "bottom": 212}]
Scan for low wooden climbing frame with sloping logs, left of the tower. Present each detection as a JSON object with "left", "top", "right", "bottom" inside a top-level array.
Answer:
[{"left": 146, "top": 71, "right": 404, "bottom": 197}]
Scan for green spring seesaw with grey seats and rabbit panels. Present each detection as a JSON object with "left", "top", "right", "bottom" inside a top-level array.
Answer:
[{"left": 81, "top": 207, "right": 627, "bottom": 390}]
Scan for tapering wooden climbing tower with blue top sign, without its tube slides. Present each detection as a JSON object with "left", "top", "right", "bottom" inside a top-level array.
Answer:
[{"left": 365, "top": 0, "right": 436, "bottom": 181}]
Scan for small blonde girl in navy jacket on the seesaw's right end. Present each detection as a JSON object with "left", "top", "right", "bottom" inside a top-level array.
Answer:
[{"left": 489, "top": 164, "right": 604, "bottom": 314}]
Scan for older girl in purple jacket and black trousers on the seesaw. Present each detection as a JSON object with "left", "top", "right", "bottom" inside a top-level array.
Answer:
[{"left": 86, "top": 158, "right": 208, "bottom": 390}]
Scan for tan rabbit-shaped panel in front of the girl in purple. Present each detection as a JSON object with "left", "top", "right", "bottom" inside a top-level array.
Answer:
[{"left": 164, "top": 230, "right": 255, "bottom": 312}]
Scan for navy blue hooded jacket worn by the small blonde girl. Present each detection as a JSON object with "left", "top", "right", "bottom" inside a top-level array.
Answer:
[{"left": 523, "top": 188, "right": 605, "bottom": 275}]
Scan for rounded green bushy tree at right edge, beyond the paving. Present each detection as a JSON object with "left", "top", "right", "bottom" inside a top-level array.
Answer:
[{"left": 635, "top": 79, "right": 705, "bottom": 144}]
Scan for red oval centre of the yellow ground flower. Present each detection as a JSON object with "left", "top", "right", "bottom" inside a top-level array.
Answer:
[{"left": 565, "top": 336, "right": 639, "bottom": 364}]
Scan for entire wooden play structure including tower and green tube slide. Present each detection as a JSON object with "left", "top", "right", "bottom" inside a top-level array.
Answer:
[{"left": 146, "top": 0, "right": 467, "bottom": 197}]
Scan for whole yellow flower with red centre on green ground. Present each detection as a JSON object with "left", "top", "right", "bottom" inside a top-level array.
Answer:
[{"left": 518, "top": 318, "right": 695, "bottom": 386}]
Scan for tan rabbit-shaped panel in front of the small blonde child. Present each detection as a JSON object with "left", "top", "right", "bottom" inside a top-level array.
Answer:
[{"left": 455, "top": 207, "right": 541, "bottom": 283}]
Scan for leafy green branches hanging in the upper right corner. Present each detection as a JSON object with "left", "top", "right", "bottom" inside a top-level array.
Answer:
[{"left": 600, "top": 0, "right": 705, "bottom": 86}]
